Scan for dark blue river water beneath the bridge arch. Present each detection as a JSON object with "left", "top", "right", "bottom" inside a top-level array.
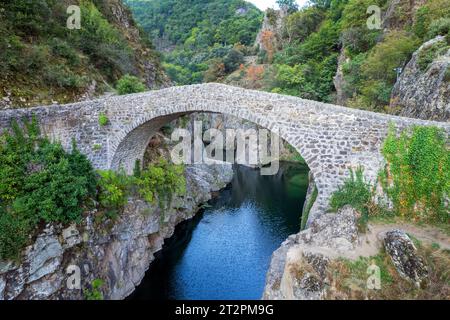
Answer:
[{"left": 130, "top": 163, "right": 308, "bottom": 300}]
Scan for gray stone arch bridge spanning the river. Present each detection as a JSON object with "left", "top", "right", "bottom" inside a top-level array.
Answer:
[{"left": 0, "top": 84, "right": 450, "bottom": 221}]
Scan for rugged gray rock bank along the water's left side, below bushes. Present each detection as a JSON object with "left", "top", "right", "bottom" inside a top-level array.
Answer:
[{"left": 0, "top": 164, "right": 233, "bottom": 299}]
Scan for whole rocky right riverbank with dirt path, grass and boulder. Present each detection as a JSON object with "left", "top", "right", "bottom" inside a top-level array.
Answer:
[{"left": 263, "top": 206, "right": 450, "bottom": 300}]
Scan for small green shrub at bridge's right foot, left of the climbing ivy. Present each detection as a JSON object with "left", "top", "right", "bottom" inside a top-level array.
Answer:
[{"left": 330, "top": 168, "right": 372, "bottom": 231}]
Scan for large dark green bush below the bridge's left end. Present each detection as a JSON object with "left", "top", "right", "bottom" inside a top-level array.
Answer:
[{"left": 0, "top": 118, "right": 96, "bottom": 259}]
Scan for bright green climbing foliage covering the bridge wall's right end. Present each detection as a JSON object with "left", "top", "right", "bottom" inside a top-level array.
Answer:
[{"left": 380, "top": 126, "right": 450, "bottom": 223}]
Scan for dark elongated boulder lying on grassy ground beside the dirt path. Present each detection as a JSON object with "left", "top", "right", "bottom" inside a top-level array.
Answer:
[{"left": 384, "top": 230, "right": 428, "bottom": 287}]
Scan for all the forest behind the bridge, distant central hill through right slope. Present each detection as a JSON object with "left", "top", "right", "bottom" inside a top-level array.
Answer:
[{"left": 126, "top": 0, "right": 450, "bottom": 112}]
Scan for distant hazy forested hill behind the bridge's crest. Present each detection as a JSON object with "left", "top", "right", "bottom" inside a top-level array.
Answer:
[{"left": 125, "top": 0, "right": 263, "bottom": 85}]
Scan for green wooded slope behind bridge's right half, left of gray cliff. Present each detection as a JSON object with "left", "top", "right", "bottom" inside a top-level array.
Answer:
[{"left": 258, "top": 0, "right": 450, "bottom": 111}]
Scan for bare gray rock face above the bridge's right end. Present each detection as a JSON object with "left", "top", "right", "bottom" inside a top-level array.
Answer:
[{"left": 391, "top": 36, "right": 450, "bottom": 122}]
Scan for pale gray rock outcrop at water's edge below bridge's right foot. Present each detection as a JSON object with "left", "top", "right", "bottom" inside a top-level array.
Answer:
[{"left": 263, "top": 207, "right": 358, "bottom": 300}]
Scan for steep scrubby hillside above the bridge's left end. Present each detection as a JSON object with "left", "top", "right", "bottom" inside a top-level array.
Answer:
[{"left": 0, "top": 0, "right": 166, "bottom": 107}]
